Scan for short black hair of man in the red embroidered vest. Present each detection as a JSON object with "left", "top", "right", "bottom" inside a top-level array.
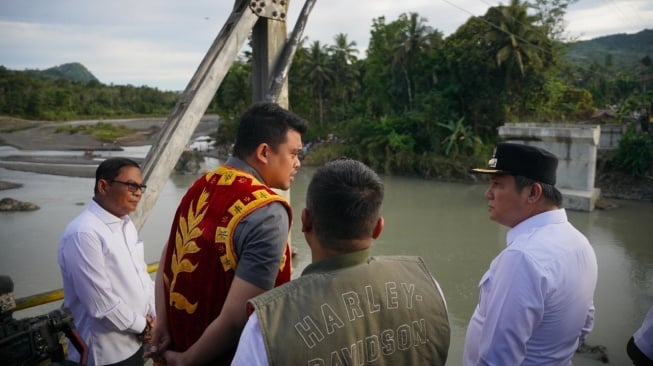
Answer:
[{"left": 233, "top": 102, "right": 308, "bottom": 159}]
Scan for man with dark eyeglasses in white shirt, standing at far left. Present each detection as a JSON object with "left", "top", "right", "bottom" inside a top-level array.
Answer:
[{"left": 58, "top": 158, "right": 155, "bottom": 366}]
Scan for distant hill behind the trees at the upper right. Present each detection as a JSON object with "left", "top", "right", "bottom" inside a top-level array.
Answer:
[{"left": 565, "top": 29, "right": 653, "bottom": 71}]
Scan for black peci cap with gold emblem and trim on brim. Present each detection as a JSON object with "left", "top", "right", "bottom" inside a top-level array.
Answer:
[{"left": 472, "top": 142, "right": 558, "bottom": 185}]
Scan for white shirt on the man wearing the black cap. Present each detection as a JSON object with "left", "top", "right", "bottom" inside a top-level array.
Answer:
[{"left": 463, "top": 209, "right": 597, "bottom": 366}]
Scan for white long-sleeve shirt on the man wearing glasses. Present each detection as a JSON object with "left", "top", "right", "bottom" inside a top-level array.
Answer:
[{"left": 58, "top": 200, "right": 155, "bottom": 366}]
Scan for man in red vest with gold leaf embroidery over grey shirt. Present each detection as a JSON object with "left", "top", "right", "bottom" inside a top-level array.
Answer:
[{"left": 149, "top": 102, "right": 307, "bottom": 365}]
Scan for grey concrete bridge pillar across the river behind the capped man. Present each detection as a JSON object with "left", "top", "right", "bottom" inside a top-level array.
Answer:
[{"left": 499, "top": 123, "right": 601, "bottom": 211}]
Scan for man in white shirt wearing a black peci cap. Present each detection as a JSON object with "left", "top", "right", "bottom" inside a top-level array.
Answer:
[{"left": 463, "top": 142, "right": 597, "bottom": 366}]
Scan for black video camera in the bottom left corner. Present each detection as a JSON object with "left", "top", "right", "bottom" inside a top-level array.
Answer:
[{"left": 0, "top": 276, "right": 88, "bottom": 366}]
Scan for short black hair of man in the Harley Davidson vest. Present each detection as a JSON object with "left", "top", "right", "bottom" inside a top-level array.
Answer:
[{"left": 306, "top": 158, "right": 384, "bottom": 251}]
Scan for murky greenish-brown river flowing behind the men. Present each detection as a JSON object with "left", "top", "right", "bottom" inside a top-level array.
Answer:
[{"left": 0, "top": 148, "right": 653, "bottom": 366}]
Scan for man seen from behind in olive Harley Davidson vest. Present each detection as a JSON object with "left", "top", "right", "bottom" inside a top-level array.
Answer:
[{"left": 232, "top": 159, "right": 450, "bottom": 366}]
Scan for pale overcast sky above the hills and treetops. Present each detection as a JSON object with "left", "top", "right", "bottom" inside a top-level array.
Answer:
[{"left": 0, "top": 0, "right": 653, "bottom": 90}]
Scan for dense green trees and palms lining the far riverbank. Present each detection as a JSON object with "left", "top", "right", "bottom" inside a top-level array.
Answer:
[{"left": 0, "top": 0, "right": 653, "bottom": 178}]
